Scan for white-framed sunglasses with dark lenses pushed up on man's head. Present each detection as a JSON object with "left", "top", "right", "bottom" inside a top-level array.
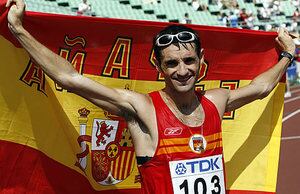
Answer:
[{"left": 156, "top": 31, "right": 196, "bottom": 46}]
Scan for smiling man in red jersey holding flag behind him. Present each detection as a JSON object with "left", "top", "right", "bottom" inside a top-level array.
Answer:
[{"left": 6, "top": 0, "right": 295, "bottom": 194}]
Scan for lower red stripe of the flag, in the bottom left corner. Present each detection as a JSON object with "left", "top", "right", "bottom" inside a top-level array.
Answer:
[{"left": 0, "top": 140, "right": 140, "bottom": 194}]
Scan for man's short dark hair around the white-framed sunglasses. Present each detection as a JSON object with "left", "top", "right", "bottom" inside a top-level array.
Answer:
[{"left": 153, "top": 25, "right": 201, "bottom": 64}]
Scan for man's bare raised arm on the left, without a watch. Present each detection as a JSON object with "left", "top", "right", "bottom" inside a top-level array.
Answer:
[{"left": 6, "top": 0, "right": 145, "bottom": 116}]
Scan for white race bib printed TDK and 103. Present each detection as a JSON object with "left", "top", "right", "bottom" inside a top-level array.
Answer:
[{"left": 169, "top": 154, "right": 225, "bottom": 194}]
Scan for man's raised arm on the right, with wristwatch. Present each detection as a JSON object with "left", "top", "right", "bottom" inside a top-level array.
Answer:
[{"left": 226, "top": 28, "right": 295, "bottom": 111}]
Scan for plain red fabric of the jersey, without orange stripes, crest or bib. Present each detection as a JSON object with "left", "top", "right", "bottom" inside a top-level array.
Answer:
[{"left": 139, "top": 92, "right": 223, "bottom": 194}]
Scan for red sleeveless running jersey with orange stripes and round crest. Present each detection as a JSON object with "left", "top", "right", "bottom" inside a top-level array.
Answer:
[{"left": 139, "top": 91, "right": 225, "bottom": 194}]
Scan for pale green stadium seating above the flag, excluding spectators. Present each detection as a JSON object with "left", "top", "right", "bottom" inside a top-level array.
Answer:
[{"left": 25, "top": 0, "right": 299, "bottom": 31}]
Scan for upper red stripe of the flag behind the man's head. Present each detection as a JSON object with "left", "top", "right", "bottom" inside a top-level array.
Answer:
[{"left": 0, "top": 0, "right": 278, "bottom": 81}]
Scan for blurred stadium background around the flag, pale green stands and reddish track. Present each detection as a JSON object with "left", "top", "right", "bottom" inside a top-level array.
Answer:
[{"left": 25, "top": 0, "right": 300, "bottom": 194}]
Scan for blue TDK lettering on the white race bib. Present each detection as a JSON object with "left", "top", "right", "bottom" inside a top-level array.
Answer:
[{"left": 185, "top": 157, "right": 220, "bottom": 173}]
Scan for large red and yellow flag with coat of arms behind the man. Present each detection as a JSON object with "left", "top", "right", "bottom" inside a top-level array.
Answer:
[{"left": 0, "top": 0, "right": 284, "bottom": 194}]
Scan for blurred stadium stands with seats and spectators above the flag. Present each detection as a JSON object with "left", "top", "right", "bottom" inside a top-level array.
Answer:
[{"left": 22, "top": 0, "right": 299, "bottom": 32}]
